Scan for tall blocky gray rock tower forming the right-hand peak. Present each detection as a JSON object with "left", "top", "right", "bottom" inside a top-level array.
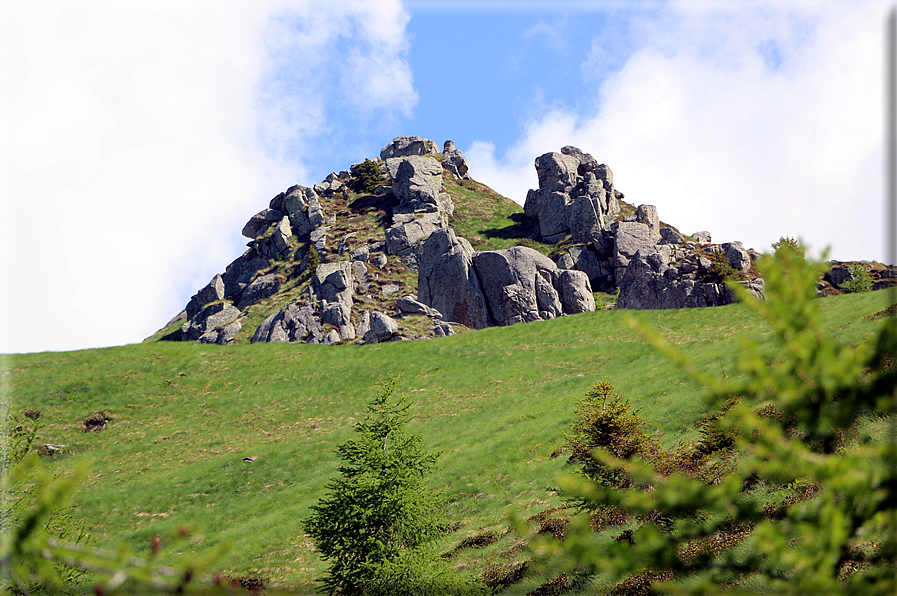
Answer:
[{"left": 523, "top": 146, "right": 619, "bottom": 243}]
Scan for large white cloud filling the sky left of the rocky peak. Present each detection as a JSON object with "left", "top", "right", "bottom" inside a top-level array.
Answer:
[{"left": 0, "top": 0, "right": 416, "bottom": 352}]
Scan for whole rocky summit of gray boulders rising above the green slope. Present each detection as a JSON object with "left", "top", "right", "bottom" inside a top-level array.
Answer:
[{"left": 149, "top": 136, "right": 897, "bottom": 344}]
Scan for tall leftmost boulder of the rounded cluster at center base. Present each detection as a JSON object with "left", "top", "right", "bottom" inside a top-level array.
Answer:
[{"left": 417, "top": 228, "right": 491, "bottom": 329}]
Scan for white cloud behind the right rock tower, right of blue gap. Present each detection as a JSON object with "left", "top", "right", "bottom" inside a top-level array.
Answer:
[{"left": 469, "top": 2, "right": 885, "bottom": 259}]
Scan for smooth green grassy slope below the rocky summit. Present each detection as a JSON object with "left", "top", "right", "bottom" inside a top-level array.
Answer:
[{"left": 7, "top": 293, "right": 886, "bottom": 593}]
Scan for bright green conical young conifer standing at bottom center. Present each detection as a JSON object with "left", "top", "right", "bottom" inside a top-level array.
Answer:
[{"left": 303, "top": 379, "right": 456, "bottom": 594}]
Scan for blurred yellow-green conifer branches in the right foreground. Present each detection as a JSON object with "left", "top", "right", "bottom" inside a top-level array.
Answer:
[{"left": 562, "top": 250, "right": 897, "bottom": 594}]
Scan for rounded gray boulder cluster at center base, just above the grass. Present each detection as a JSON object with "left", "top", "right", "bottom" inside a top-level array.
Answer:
[{"left": 418, "top": 230, "right": 595, "bottom": 329}]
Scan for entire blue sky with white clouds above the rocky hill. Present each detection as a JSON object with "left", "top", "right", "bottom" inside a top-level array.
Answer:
[{"left": 0, "top": 0, "right": 891, "bottom": 353}]
